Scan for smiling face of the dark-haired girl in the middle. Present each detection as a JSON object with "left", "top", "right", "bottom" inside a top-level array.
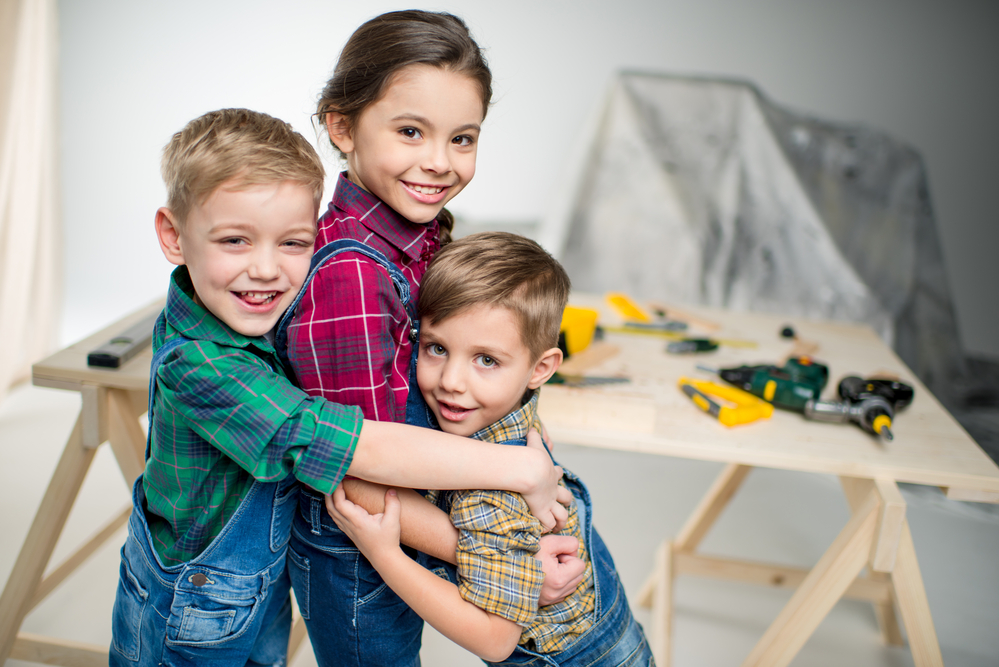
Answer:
[{"left": 326, "top": 65, "right": 482, "bottom": 224}]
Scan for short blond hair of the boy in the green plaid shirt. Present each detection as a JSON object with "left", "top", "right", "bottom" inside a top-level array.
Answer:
[{"left": 160, "top": 109, "right": 325, "bottom": 224}]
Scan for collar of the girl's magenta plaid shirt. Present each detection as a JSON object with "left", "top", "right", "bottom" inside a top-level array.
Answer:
[{"left": 329, "top": 171, "right": 438, "bottom": 261}]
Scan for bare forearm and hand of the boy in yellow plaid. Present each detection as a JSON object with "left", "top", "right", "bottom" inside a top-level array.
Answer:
[{"left": 327, "top": 488, "right": 521, "bottom": 662}]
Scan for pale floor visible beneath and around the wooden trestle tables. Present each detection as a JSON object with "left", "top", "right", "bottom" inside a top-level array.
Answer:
[{"left": 0, "top": 385, "right": 999, "bottom": 667}]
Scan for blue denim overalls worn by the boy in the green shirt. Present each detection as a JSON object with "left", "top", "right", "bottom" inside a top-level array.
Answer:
[{"left": 110, "top": 322, "right": 298, "bottom": 667}]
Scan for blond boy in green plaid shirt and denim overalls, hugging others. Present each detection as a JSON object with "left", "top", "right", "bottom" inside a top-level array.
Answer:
[{"left": 111, "top": 109, "right": 563, "bottom": 666}]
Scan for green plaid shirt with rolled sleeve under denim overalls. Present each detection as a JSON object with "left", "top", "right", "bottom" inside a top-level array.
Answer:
[{"left": 143, "top": 266, "right": 362, "bottom": 565}]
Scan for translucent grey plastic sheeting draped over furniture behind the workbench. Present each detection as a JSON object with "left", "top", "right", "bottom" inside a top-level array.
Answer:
[{"left": 544, "top": 73, "right": 965, "bottom": 402}]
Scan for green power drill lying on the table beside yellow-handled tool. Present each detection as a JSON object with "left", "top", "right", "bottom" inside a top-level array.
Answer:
[{"left": 698, "top": 357, "right": 829, "bottom": 412}]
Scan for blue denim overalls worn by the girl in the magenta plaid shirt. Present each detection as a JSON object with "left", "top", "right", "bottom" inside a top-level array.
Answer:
[{"left": 275, "top": 239, "right": 457, "bottom": 667}]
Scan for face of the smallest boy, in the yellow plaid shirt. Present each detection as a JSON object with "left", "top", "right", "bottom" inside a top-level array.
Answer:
[{"left": 416, "top": 305, "right": 562, "bottom": 436}]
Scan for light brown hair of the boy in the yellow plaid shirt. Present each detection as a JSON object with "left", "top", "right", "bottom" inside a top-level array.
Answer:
[{"left": 417, "top": 232, "right": 570, "bottom": 361}]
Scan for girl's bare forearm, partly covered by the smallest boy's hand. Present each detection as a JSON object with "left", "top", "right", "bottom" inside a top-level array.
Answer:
[{"left": 343, "top": 479, "right": 458, "bottom": 565}]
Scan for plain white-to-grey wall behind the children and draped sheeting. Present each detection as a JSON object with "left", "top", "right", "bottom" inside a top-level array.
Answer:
[{"left": 58, "top": 0, "right": 999, "bottom": 359}]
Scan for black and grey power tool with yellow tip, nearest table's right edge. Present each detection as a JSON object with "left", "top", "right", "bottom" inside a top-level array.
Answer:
[{"left": 804, "top": 375, "right": 913, "bottom": 440}]
